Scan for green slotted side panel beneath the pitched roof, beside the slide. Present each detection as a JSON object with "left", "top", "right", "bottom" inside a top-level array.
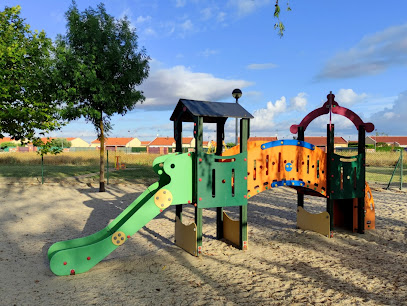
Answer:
[{"left": 196, "top": 152, "right": 247, "bottom": 208}]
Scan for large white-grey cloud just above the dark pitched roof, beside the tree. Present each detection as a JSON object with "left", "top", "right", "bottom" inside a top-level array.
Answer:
[{"left": 137, "top": 62, "right": 252, "bottom": 110}]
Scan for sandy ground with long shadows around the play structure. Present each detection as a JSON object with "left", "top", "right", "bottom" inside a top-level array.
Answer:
[{"left": 0, "top": 183, "right": 407, "bottom": 305}]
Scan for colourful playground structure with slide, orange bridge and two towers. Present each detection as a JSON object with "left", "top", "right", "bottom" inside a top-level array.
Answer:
[{"left": 48, "top": 93, "right": 375, "bottom": 275}]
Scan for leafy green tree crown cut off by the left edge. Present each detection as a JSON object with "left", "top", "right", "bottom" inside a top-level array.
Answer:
[{"left": 0, "top": 6, "right": 61, "bottom": 142}]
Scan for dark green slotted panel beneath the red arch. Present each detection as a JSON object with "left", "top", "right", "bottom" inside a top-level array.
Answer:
[{"left": 329, "top": 154, "right": 365, "bottom": 199}]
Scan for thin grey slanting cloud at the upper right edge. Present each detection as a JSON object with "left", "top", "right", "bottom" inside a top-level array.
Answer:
[{"left": 317, "top": 23, "right": 407, "bottom": 79}]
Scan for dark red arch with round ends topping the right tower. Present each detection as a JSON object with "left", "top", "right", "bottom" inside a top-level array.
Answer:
[{"left": 290, "top": 93, "right": 374, "bottom": 134}]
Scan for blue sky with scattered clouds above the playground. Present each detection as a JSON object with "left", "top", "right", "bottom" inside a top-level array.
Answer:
[{"left": 0, "top": 0, "right": 407, "bottom": 142}]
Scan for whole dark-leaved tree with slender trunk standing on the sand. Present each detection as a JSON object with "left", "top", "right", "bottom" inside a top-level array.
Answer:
[{"left": 56, "top": 2, "right": 149, "bottom": 191}]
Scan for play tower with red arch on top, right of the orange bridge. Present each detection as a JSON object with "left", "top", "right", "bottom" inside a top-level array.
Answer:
[{"left": 290, "top": 92, "right": 375, "bottom": 236}]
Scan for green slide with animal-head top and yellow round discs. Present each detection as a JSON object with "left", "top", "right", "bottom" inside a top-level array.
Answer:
[{"left": 48, "top": 153, "right": 192, "bottom": 275}]
